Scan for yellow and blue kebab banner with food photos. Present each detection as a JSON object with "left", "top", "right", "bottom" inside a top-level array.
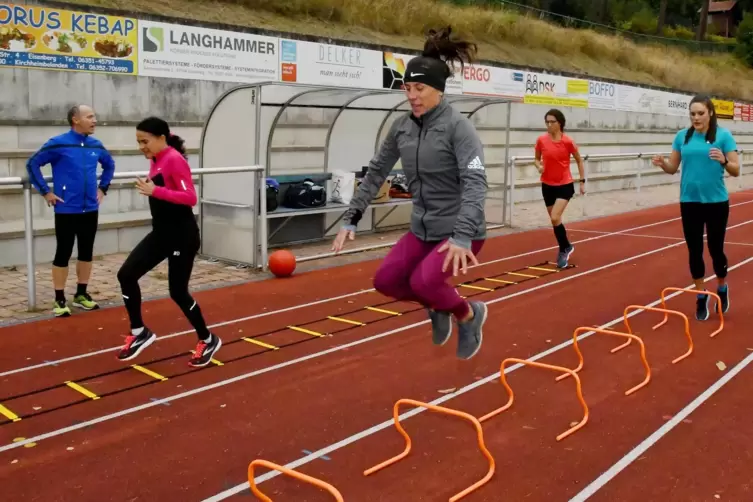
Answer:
[{"left": 0, "top": 4, "right": 138, "bottom": 75}]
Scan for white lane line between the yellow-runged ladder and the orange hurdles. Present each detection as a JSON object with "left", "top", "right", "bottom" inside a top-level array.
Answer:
[{"left": 0, "top": 220, "right": 753, "bottom": 453}]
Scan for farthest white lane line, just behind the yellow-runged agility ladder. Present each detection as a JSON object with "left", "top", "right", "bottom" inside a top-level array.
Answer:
[{"left": 0, "top": 200, "right": 753, "bottom": 377}]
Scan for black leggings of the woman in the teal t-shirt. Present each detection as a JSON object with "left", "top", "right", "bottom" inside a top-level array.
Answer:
[{"left": 680, "top": 201, "right": 729, "bottom": 279}]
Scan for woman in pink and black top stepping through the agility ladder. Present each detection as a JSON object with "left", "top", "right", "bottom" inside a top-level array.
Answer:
[{"left": 118, "top": 117, "right": 222, "bottom": 367}]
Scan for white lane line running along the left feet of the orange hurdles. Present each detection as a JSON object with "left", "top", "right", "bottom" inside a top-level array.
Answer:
[{"left": 202, "top": 262, "right": 753, "bottom": 502}]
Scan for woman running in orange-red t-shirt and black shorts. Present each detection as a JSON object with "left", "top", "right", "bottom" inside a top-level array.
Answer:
[{"left": 535, "top": 109, "right": 586, "bottom": 268}]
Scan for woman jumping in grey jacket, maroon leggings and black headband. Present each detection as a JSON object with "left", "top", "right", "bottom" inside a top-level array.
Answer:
[{"left": 332, "top": 27, "right": 487, "bottom": 359}]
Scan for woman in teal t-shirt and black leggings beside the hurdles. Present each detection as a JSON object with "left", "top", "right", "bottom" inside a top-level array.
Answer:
[{"left": 653, "top": 96, "right": 740, "bottom": 321}]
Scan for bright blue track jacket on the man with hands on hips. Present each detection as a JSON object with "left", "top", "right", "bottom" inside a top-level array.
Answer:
[{"left": 26, "top": 129, "right": 115, "bottom": 214}]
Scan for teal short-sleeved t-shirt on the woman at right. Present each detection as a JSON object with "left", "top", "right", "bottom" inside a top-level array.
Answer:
[{"left": 672, "top": 127, "right": 737, "bottom": 202}]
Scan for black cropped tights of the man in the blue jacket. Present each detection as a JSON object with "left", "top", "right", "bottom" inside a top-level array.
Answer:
[{"left": 52, "top": 211, "right": 99, "bottom": 267}]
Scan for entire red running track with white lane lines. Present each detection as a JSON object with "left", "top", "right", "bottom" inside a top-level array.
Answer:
[{"left": 0, "top": 194, "right": 753, "bottom": 501}]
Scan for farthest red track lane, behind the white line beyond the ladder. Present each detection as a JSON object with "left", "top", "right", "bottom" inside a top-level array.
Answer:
[{"left": 5, "top": 193, "right": 751, "bottom": 377}]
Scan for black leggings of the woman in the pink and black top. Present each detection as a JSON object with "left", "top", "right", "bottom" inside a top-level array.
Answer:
[{"left": 118, "top": 231, "right": 209, "bottom": 340}]
